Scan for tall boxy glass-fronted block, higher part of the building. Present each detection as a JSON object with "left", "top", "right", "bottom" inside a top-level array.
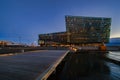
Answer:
[{"left": 65, "top": 16, "right": 111, "bottom": 44}]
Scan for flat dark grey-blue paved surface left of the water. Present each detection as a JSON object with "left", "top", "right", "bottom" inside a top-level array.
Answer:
[{"left": 0, "top": 50, "right": 67, "bottom": 80}]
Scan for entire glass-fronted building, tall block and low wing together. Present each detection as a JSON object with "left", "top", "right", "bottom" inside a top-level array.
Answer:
[{"left": 38, "top": 16, "right": 111, "bottom": 45}]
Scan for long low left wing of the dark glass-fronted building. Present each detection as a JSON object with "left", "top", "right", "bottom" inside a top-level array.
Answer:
[{"left": 38, "top": 32, "right": 67, "bottom": 45}]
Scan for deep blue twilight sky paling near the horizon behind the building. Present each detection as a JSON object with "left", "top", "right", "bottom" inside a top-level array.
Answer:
[{"left": 0, "top": 0, "right": 120, "bottom": 44}]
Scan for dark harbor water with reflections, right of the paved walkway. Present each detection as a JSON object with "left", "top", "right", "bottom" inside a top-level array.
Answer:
[{"left": 48, "top": 52, "right": 120, "bottom": 80}]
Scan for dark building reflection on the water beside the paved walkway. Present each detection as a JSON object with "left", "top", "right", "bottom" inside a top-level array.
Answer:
[{"left": 57, "top": 53, "right": 111, "bottom": 80}]
